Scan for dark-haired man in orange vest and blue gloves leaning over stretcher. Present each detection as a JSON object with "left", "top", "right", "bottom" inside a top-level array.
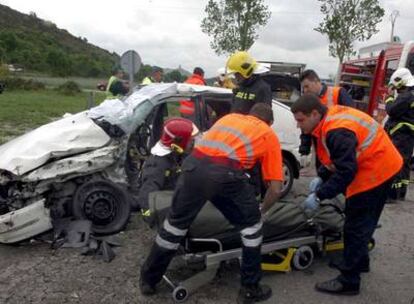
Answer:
[{"left": 291, "top": 94, "right": 402, "bottom": 295}]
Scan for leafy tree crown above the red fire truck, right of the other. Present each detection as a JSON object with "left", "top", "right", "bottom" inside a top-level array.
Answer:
[{"left": 315, "top": 0, "right": 384, "bottom": 64}]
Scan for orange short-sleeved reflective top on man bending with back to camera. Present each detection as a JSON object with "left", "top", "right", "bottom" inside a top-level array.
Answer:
[{"left": 194, "top": 113, "right": 283, "bottom": 181}]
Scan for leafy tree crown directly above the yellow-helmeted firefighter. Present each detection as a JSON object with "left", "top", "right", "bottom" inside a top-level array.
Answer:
[{"left": 201, "top": 0, "right": 271, "bottom": 55}]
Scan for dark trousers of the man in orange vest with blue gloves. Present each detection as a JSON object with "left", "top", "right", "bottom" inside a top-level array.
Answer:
[{"left": 339, "top": 179, "right": 392, "bottom": 285}]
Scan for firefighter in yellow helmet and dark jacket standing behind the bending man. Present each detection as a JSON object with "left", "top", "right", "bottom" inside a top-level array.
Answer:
[{"left": 226, "top": 51, "right": 272, "bottom": 114}]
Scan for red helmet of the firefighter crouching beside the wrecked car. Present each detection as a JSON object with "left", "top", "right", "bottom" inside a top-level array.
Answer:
[{"left": 161, "top": 117, "right": 198, "bottom": 150}]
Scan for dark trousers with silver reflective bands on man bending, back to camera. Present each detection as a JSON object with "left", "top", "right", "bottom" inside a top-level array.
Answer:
[{"left": 141, "top": 155, "right": 262, "bottom": 286}]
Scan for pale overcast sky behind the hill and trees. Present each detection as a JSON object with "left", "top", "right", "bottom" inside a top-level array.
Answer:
[{"left": 0, "top": 0, "right": 414, "bottom": 77}]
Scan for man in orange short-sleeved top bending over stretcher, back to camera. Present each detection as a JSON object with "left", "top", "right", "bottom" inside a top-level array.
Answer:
[{"left": 140, "top": 104, "right": 283, "bottom": 303}]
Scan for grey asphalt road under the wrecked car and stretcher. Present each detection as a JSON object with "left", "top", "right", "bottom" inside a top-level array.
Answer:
[{"left": 0, "top": 178, "right": 414, "bottom": 304}]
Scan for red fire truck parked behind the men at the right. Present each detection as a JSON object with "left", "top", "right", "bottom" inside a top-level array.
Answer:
[{"left": 340, "top": 41, "right": 414, "bottom": 122}]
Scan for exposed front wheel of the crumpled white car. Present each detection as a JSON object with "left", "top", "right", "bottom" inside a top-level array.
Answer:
[{"left": 72, "top": 180, "right": 131, "bottom": 234}]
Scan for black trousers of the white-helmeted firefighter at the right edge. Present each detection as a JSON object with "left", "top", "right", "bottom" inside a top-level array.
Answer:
[{"left": 389, "top": 129, "right": 414, "bottom": 200}]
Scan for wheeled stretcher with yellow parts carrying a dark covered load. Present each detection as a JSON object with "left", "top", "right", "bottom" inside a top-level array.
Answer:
[{"left": 149, "top": 191, "right": 344, "bottom": 303}]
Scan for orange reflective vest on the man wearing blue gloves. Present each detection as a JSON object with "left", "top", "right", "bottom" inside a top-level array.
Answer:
[{"left": 312, "top": 106, "right": 403, "bottom": 197}]
